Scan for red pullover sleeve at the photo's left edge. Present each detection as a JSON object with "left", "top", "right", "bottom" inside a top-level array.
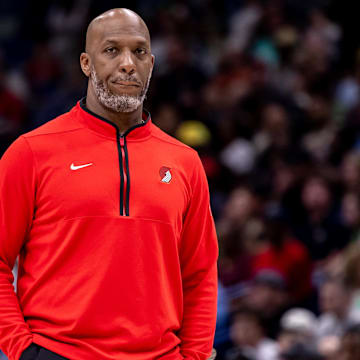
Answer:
[{"left": 0, "top": 137, "right": 35, "bottom": 360}]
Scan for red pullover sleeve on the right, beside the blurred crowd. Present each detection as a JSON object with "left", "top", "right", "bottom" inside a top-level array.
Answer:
[{"left": 178, "top": 156, "right": 218, "bottom": 360}]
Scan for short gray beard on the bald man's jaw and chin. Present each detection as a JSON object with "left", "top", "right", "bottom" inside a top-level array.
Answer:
[{"left": 90, "top": 66, "right": 151, "bottom": 113}]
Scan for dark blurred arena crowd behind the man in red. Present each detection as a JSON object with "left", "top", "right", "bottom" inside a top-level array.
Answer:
[{"left": 0, "top": 0, "right": 360, "bottom": 360}]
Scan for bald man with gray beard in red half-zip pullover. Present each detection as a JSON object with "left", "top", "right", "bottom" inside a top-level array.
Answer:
[{"left": 0, "top": 9, "right": 218, "bottom": 360}]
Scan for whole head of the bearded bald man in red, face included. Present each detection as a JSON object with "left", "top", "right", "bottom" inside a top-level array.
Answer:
[{"left": 80, "top": 9, "right": 154, "bottom": 120}]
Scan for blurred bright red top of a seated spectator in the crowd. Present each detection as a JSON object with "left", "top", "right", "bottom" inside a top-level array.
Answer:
[{"left": 253, "top": 238, "right": 312, "bottom": 301}]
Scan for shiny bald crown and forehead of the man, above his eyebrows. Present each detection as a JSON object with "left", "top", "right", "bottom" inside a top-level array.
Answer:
[{"left": 85, "top": 8, "right": 150, "bottom": 53}]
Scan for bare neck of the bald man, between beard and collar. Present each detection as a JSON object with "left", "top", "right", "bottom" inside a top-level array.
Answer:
[{"left": 86, "top": 89, "right": 143, "bottom": 134}]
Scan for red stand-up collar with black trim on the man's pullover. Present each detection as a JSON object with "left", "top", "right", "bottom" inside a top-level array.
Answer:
[{"left": 76, "top": 97, "right": 152, "bottom": 141}]
